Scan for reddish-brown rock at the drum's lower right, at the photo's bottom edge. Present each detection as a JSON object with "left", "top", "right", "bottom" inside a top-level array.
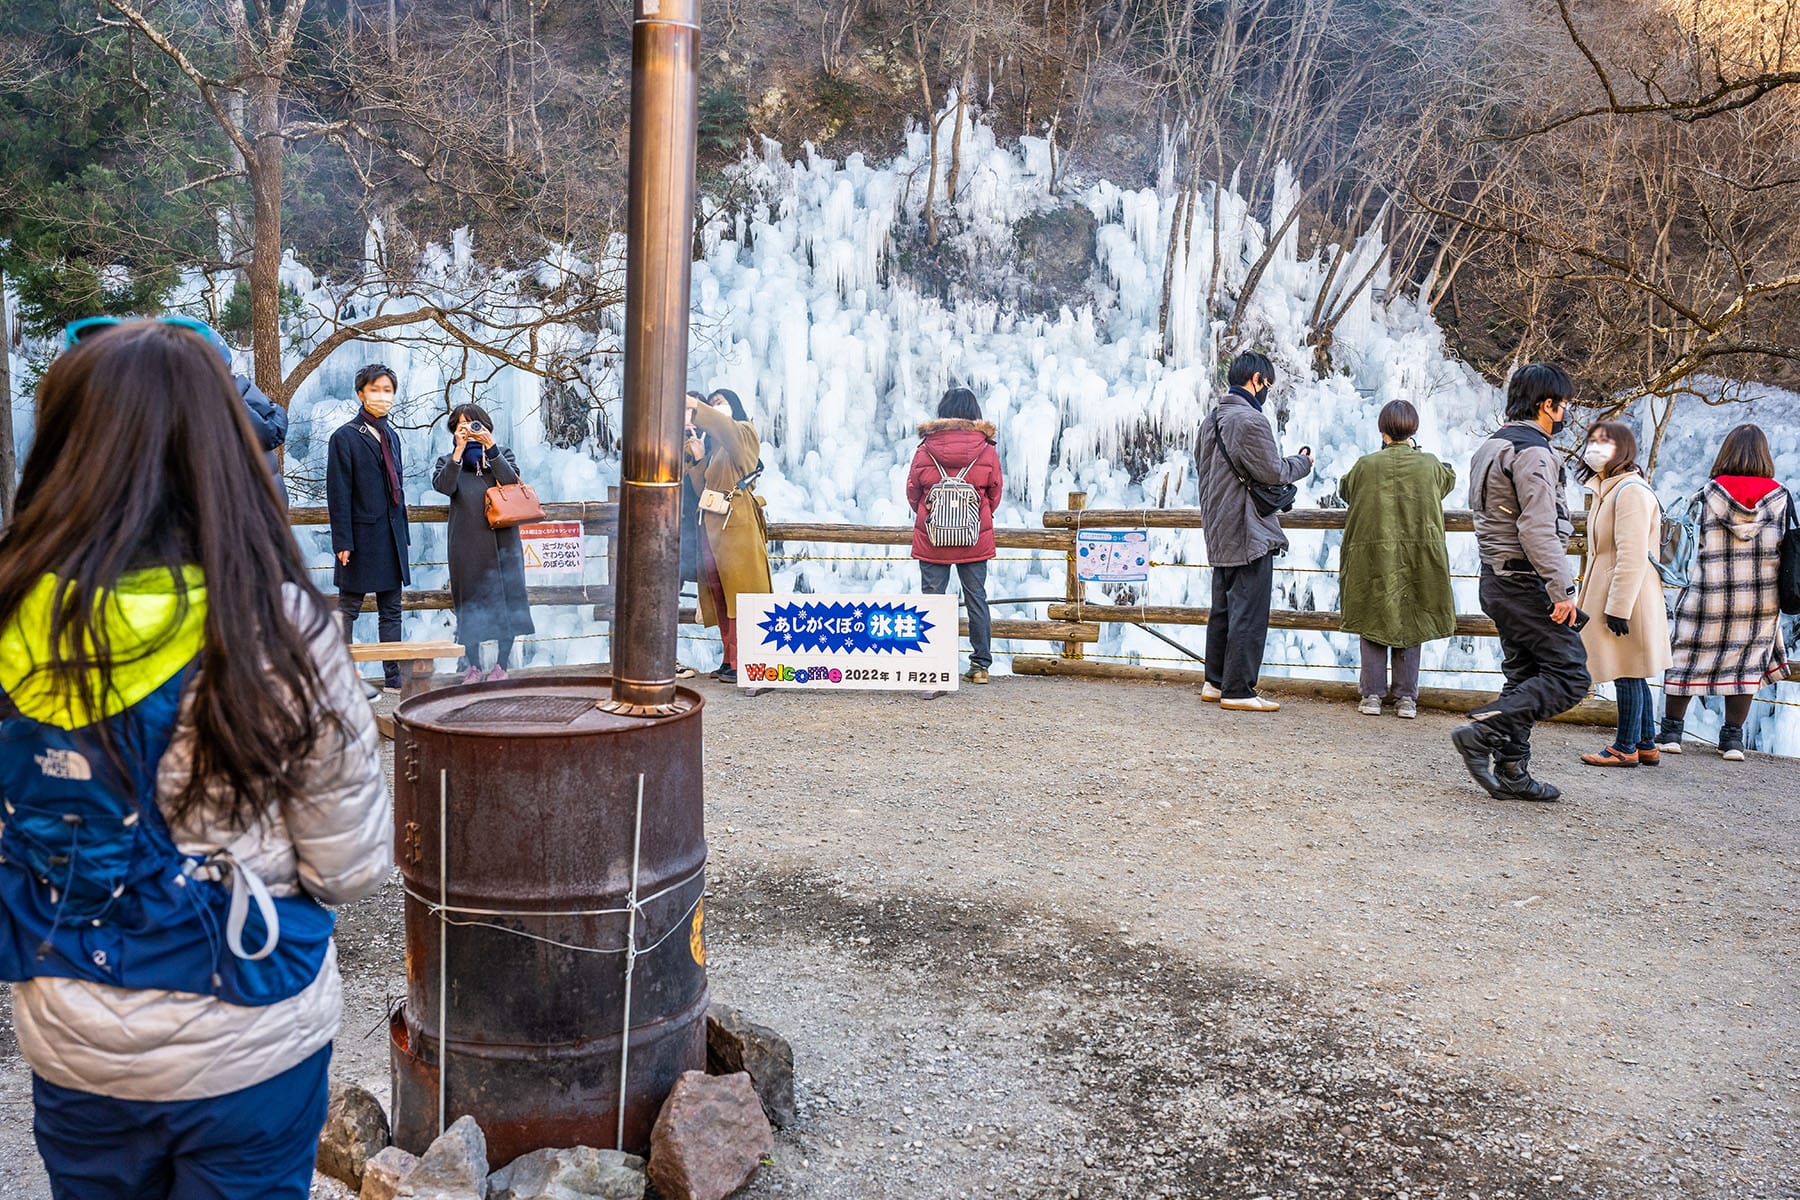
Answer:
[{"left": 650, "top": 1070, "right": 776, "bottom": 1200}]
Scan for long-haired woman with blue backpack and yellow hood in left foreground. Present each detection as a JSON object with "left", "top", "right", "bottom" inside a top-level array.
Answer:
[{"left": 0, "top": 322, "right": 392, "bottom": 1200}]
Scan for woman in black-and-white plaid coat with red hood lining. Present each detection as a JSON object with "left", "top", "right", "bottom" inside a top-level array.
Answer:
[{"left": 1656, "top": 425, "right": 1793, "bottom": 763}]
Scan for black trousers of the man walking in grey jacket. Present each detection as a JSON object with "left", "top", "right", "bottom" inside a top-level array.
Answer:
[{"left": 1471, "top": 567, "right": 1589, "bottom": 759}]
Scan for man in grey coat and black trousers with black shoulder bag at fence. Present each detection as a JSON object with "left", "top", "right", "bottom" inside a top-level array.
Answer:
[{"left": 1193, "top": 351, "right": 1312, "bottom": 712}]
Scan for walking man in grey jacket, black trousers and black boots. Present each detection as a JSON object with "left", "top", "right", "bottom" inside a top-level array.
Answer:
[{"left": 1451, "top": 363, "right": 1588, "bottom": 801}]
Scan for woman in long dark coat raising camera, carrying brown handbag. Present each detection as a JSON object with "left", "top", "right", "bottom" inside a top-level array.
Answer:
[{"left": 432, "top": 405, "right": 535, "bottom": 684}]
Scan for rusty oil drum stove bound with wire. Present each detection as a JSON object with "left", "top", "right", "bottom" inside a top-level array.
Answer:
[{"left": 391, "top": 676, "right": 707, "bottom": 1166}]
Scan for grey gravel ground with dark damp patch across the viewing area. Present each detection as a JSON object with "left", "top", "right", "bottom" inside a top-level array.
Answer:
[{"left": 0, "top": 678, "right": 1800, "bottom": 1200}]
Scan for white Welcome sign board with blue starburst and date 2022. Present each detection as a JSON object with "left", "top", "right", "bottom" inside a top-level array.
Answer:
[{"left": 738, "top": 594, "right": 959, "bottom": 691}]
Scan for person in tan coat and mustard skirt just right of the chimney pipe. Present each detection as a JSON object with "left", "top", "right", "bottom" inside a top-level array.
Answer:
[{"left": 686, "top": 387, "right": 772, "bottom": 684}]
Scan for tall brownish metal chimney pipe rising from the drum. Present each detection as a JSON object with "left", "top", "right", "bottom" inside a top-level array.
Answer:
[{"left": 601, "top": 0, "right": 700, "bottom": 716}]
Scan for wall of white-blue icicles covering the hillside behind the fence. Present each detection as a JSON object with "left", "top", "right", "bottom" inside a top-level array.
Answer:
[{"left": 3, "top": 108, "right": 1800, "bottom": 754}]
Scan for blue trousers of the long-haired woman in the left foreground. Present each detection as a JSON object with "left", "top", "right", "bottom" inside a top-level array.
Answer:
[{"left": 31, "top": 1045, "right": 331, "bottom": 1200}]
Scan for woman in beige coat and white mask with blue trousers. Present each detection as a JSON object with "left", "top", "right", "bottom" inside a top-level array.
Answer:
[{"left": 1577, "top": 421, "right": 1670, "bottom": 766}]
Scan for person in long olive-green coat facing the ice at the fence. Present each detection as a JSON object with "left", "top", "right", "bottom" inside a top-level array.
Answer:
[{"left": 1337, "top": 399, "right": 1456, "bottom": 720}]
